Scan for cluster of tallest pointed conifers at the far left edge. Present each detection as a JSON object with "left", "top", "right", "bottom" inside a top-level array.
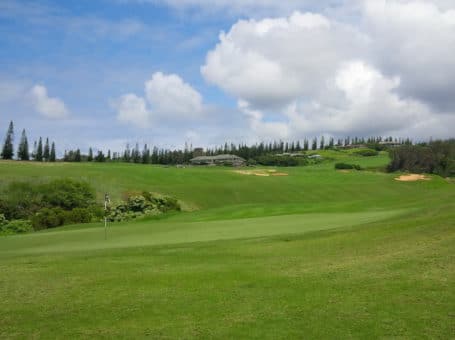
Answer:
[{"left": 1, "top": 121, "right": 57, "bottom": 162}]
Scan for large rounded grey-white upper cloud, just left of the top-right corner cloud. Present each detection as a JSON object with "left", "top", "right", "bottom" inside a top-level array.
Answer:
[{"left": 201, "top": 12, "right": 366, "bottom": 108}]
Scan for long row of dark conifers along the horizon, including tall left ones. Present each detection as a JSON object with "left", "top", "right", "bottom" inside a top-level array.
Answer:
[{"left": 1, "top": 122, "right": 412, "bottom": 165}]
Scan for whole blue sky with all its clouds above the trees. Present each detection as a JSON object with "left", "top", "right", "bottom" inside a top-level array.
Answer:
[{"left": 0, "top": 0, "right": 455, "bottom": 151}]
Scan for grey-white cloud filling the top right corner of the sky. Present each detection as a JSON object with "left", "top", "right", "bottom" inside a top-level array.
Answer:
[{"left": 362, "top": 0, "right": 455, "bottom": 111}]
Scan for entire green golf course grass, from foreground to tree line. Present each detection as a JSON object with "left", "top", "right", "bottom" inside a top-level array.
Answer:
[{"left": 0, "top": 156, "right": 455, "bottom": 339}]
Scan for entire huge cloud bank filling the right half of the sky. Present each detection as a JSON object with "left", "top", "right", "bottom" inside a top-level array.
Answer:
[{"left": 201, "top": 0, "right": 455, "bottom": 138}]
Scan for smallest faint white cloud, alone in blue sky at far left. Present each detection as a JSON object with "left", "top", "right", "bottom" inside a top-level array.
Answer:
[{"left": 30, "top": 85, "right": 69, "bottom": 119}]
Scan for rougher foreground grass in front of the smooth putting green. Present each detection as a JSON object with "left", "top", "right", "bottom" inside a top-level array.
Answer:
[{"left": 0, "top": 207, "right": 455, "bottom": 338}]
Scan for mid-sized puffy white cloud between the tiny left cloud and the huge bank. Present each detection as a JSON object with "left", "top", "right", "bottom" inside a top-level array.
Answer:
[{"left": 114, "top": 72, "right": 205, "bottom": 128}]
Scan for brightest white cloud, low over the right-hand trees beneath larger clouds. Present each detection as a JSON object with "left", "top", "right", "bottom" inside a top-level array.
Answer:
[{"left": 285, "top": 61, "right": 430, "bottom": 134}]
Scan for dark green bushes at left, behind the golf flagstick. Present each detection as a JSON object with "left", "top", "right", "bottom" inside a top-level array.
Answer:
[{"left": 0, "top": 178, "right": 181, "bottom": 234}]
